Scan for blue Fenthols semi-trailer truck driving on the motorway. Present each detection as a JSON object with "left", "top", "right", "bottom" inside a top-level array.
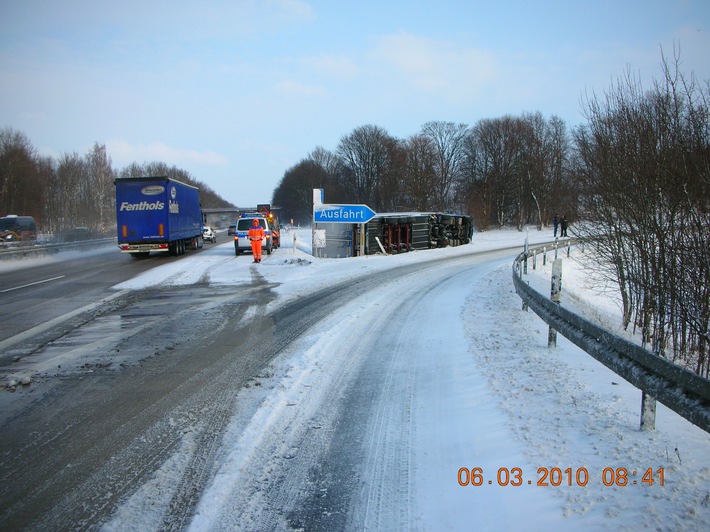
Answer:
[{"left": 114, "top": 176, "right": 204, "bottom": 257}]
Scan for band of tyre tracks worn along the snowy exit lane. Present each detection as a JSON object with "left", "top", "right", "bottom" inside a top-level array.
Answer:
[{"left": 192, "top": 251, "right": 516, "bottom": 531}]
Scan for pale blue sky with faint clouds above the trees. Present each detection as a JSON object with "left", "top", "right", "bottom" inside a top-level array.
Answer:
[{"left": 0, "top": 0, "right": 710, "bottom": 206}]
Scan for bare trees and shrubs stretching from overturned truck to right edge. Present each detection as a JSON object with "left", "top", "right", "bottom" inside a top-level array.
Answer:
[{"left": 272, "top": 55, "right": 710, "bottom": 377}]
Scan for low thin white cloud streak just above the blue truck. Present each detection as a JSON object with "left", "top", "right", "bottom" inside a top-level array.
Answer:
[{"left": 106, "top": 139, "right": 229, "bottom": 166}]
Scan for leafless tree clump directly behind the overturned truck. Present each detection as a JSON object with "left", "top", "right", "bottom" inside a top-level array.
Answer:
[{"left": 272, "top": 113, "right": 576, "bottom": 229}]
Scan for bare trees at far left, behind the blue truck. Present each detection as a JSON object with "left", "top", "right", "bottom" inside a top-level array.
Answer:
[{"left": 0, "top": 135, "right": 234, "bottom": 239}]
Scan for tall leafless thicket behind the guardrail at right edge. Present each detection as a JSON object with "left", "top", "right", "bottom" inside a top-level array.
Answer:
[{"left": 575, "top": 51, "right": 710, "bottom": 375}]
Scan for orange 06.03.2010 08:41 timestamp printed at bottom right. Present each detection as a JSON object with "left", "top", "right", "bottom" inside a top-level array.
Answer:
[{"left": 458, "top": 467, "right": 665, "bottom": 487}]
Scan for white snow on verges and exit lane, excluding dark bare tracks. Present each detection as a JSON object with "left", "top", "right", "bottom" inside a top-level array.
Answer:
[{"left": 100, "top": 230, "right": 710, "bottom": 530}]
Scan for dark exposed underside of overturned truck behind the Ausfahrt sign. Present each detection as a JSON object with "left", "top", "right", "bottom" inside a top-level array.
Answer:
[{"left": 365, "top": 212, "right": 473, "bottom": 255}]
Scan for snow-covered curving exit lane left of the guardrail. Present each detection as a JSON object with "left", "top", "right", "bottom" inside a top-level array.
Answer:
[{"left": 184, "top": 247, "right": 568, "bottom": 530}]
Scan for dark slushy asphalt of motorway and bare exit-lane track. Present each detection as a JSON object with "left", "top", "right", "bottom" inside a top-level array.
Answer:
[{"left": 0, "top": 244, "right": 524, "bottom": 530}]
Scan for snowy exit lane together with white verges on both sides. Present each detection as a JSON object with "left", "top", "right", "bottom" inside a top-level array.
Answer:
[{"left": 2, "top": 227, "right": 710, "bottom": 531}]
